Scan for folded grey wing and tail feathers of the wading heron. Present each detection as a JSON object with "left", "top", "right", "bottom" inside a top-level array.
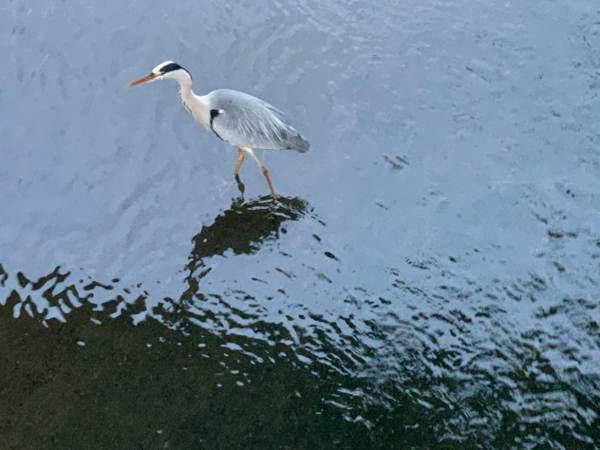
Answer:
[{"left": 208, "top": 89, "right": 310, "bottom": 152}]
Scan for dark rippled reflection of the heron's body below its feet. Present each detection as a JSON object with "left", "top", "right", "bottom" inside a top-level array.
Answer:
[{"left": 187, "top": 196, "right": 309, "bottom": 274}]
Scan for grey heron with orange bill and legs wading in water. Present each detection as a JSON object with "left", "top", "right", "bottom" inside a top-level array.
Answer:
[{"left": 126, "top": 61, "right": 310, "bottom": 199}]
